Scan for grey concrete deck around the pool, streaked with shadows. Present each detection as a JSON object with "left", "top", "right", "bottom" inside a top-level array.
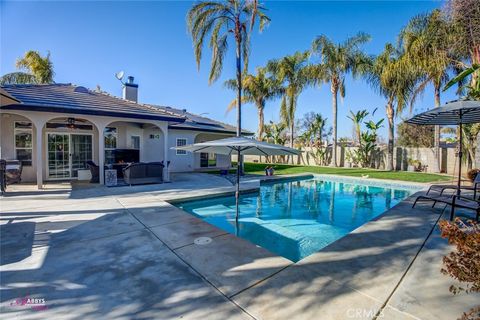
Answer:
[{"left": 0, "top": 174, "right": 480, "bottom": 320}]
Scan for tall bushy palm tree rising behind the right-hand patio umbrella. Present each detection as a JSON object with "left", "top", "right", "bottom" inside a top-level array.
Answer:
[{"left": 399, "top": 10, "right": 457, "bottom": 172}]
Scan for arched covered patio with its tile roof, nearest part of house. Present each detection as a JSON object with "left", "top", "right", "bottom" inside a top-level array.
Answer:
[{"left": 0, "top": 85, "right": 185, "bottom": 188}]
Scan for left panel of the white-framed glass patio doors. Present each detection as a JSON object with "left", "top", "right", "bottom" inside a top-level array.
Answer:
[{"left": 48, "top": 133, "right": 70, "bottom": 179}]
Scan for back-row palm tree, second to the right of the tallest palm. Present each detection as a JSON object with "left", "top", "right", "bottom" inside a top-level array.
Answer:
[{"left": 267, "top": 52, "right": 309, "bottom": 163}]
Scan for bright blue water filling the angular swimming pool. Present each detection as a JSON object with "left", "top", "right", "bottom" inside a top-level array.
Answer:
[{"left": 176, "top": 177, "right": 415, "bottom": 261}]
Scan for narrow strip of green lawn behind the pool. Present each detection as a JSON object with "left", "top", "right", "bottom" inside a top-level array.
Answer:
[{"left": 225, "top": 162, "right": 452, "bottom": 182}]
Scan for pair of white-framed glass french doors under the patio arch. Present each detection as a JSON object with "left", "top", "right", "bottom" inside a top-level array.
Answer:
[{"left": 47, "top": 133, "right": 93, "bottom": 180}]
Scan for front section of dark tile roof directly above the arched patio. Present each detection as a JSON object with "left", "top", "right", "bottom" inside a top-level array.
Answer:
[{"left": 1, "top": 83, "right": 185, "bottom": 122}]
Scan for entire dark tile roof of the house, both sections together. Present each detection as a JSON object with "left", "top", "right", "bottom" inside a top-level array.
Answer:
[{"left": 0, "top": 83, "right": 253, "bottom": 135}]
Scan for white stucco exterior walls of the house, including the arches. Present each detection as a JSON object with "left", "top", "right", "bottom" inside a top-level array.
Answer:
[{"left": 0, "top": 110, "right": 236, "bottom": 182}]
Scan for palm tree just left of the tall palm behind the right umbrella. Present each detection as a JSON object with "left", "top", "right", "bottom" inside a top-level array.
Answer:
[{"left": 368, "top": 43, "right": 417, "bottom": 170}]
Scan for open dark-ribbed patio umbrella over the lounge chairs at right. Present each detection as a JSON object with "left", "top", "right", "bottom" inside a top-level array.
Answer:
[{"left": 406, "top": 100, "right": 480, "bottom": 195}]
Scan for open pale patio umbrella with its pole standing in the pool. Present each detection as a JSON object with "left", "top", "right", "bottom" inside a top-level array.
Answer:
[{"left": 172, "top": 137, "right": 301, "bottom": 220}]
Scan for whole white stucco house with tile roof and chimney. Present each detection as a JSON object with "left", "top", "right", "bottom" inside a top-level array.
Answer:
[{"left": 0, "top": 77, "right": 248, "bottom": 188}]
